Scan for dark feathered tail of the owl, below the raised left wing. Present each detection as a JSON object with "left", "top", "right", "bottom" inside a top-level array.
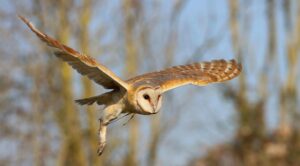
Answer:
[{"left": 75, "top": 92, "right": 111, "bottom": 105}]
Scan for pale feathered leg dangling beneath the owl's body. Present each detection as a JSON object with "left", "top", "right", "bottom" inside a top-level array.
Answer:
[{"left": 97, "top": 108, "right": 122, "bottom": 156}]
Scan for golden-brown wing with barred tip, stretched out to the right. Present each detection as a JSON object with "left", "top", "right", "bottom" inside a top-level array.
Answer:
[{"left": 127, "top": 59, "right": 242, "bottom": 92}]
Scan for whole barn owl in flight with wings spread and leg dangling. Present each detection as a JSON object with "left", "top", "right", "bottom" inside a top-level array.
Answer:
[{"left": 19, "top": 16, "right": 242, "bottom": 155}]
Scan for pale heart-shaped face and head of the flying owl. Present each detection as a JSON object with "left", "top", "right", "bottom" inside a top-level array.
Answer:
[{"left": 133, "top": 86, "right": 162, "bottom": 114}]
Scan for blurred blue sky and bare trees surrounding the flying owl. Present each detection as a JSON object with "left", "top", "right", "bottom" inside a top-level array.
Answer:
[{"left": 0, "top": 0, "right": 300, "bottom": 166}]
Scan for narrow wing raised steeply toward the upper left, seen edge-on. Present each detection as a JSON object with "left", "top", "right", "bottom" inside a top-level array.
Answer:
[{"left": 19, "top": 16, "right": 128, "bottom": 90}]
